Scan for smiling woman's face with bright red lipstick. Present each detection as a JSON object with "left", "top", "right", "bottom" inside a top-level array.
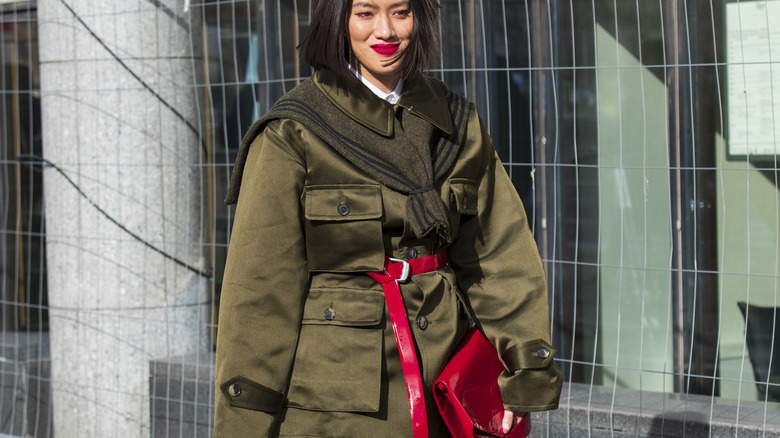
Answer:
[{"left": 347, "top": 0, "right": 414, "bottom": 93}]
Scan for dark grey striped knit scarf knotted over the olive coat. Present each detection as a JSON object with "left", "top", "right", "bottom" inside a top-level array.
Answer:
[{"left": 225, "top": 72, "right": 468, "bottom": 250}]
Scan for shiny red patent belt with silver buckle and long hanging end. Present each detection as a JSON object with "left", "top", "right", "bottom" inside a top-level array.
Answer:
[{"left": 367, "top": 251, "right": 447, "bottom": 438}]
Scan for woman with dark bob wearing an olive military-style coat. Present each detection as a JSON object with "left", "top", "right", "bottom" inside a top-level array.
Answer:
[{"left": 215, "top": 0, "right": 561, "bottom": 437}]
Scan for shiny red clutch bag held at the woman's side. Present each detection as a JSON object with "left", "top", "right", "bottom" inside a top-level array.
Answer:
[{"left": 433, "top": 327, "right": 531, "bottom": 438}]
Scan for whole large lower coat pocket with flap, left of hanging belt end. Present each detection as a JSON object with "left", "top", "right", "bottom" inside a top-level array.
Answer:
[{"left": 288, "top": 289, "right": 385, "bottom": 412}]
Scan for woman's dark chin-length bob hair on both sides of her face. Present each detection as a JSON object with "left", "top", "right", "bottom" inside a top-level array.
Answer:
[{"left": 298, "top": 0, "right": 441, "bottom": 81}]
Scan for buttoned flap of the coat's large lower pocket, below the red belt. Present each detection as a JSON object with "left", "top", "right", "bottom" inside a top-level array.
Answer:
[{"left": 303, "top": 289, "right": 385, "bottom": 326}]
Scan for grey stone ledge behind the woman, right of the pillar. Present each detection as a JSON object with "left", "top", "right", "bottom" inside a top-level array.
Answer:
[{"left": 150, "top": 353, "right": 780, "bottom": 438}]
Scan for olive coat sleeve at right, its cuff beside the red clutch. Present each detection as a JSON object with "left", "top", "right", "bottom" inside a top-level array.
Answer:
[{"left": 449, "top": 110, "right": 562, "bottom": 412}]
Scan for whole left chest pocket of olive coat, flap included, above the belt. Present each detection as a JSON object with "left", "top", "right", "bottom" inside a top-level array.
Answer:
[{"left": 304, "top": 184, "right": 384, "bottom": 272}]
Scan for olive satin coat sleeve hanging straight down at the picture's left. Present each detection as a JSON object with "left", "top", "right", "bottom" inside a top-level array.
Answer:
[{"left": 214, "top": 121, "right": 309, "bottom": 437}]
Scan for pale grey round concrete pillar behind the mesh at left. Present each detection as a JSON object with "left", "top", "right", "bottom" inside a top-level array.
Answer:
[{"left": 38, "top": 0, "right": 210, "bottom": 437}]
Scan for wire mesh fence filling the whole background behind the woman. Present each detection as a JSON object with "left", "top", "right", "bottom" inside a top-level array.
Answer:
[{"left": 0, "top": 0, "right": 780, "bottom": 437}]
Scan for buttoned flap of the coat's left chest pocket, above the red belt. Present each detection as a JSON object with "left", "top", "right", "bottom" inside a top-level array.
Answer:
[{"left": 305, "top": 184, "right": 382, "bottom": 221}]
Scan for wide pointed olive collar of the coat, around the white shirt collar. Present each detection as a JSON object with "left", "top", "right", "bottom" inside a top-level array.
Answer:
[{"left": 313, "top": 70, "right": 452, "bottom": 137}]
